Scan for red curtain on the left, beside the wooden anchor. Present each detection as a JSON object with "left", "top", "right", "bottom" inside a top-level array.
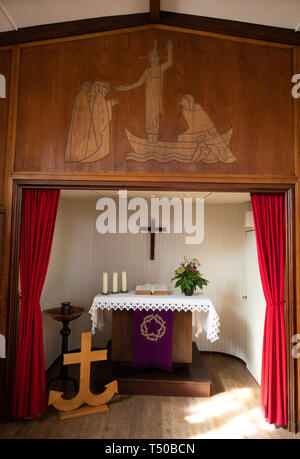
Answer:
[{"left": 13, "top": 189, "right": 60, "bottom": 419}]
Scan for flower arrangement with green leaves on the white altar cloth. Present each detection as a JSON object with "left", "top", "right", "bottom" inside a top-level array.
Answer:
[{"left": 172, "top": 257, "right": 209, "bottom": 295}]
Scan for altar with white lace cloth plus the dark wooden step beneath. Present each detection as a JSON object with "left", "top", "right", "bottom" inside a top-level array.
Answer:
[{"left": 89, "top": 291, "right": 220, "bottom": 397}]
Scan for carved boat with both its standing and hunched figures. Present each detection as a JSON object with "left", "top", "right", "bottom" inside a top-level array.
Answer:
[{"left": 116, "top": 40, "right": 235, "bottom": 163}]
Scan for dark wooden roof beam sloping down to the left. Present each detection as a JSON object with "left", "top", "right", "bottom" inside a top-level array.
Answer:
[{"left": 0, "top": 13, "right": 150, "bottom": 46}]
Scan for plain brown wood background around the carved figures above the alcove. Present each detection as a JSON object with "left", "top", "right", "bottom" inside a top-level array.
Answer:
[{"left": 15, "top": 29, "right": 294, "bottom": 176}]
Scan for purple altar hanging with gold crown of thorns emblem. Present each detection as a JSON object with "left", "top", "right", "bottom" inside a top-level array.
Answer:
[{"left": 132, "top": 309, "right": 173, "bottom": 371}]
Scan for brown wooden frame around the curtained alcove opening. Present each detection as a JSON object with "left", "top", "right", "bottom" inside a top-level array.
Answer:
[{"left": 4, "top": 176, "right": 298, "bottom": 433}]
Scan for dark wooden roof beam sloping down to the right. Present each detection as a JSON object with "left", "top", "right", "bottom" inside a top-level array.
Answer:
[{"left": 160, "top": 11, "right": 300, "bottom": 46}]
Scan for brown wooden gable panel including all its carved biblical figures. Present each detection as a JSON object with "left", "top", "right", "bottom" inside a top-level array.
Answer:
[{"left": 15, "top": 29, "right": 294, "bottom": 176}]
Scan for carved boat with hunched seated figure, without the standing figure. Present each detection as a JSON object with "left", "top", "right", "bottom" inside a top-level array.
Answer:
[{"left": 126, "top": 94, "right": 236, "bottom": 163}]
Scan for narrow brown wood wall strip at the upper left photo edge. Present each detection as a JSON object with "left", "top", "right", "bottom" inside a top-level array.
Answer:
[{"left": 0, "top": 49, "right": 12, "bottom": 207}]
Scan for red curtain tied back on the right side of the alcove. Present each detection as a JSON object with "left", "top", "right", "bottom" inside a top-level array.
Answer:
[{"left": 251, "top": 194, "right": 287, "bottom": 425}]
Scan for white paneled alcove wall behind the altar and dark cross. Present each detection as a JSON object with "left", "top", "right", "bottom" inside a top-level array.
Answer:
[{"left": 41, "top": 199, "right": 262, "bottom": 378}]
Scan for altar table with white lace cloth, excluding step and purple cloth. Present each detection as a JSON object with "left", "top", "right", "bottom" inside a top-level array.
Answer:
[{"left": 89, "top": 291, "right": 220, "bottom": 363}]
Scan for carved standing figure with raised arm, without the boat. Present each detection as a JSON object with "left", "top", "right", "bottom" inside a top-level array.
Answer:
[{"left": 116, "top": 40, "right": 173, "bottom": 143}]
